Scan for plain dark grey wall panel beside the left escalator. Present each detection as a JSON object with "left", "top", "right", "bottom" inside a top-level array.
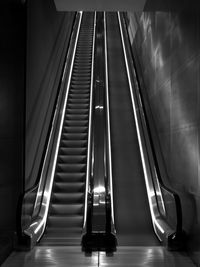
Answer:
[{"left": 25, "top": 0, "right": 74, "bottom": 189}]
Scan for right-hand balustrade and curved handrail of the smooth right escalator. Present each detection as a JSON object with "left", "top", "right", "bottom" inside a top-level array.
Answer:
[{"left": 118, "top": 12, "right": 182, "bottom": 247}]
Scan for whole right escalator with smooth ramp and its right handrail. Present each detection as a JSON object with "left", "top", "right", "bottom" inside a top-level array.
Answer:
[{"left": 106, "top": 12, "right": 185, "bottom": 250}]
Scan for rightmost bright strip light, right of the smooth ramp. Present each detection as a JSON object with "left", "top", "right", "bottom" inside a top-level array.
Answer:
[{"left": 117, "top": 11, "right": 165, "bottom": 239}]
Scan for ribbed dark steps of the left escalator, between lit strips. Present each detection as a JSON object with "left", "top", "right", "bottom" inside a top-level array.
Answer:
[{"left": 40, "top": 13, "right": 94, "bottom": 245}]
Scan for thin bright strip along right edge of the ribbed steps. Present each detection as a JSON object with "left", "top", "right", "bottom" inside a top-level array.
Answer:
[{"left": 83, "top": 12, "right": 99, "bottom": 228}]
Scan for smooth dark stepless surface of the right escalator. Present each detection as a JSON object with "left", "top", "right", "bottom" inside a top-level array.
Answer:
[{"left": 107, "top": 13, "right": 159, "bottom": 246}]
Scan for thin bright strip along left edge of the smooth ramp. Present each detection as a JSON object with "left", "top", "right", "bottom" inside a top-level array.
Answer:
[{"left": 104, "top": 12, "right": 115, "bottom": 229}]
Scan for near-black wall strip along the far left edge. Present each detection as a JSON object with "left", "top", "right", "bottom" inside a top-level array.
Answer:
[{"left": 0, "top": 1, "right": 25, "bottom": 264}]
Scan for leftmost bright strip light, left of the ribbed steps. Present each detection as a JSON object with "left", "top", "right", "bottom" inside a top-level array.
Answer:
[{"left": 30, "top": 11, "right": 83, "bottom": 237}]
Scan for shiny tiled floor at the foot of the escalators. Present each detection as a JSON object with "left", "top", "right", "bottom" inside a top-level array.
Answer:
[{"left": 2, "top": 247, "right": 194, "bottom": 267}]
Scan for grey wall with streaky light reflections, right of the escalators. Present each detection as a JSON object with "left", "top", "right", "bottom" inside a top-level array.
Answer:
[{"left": 127, "top": 9, "right": 200, "bottom": 264}]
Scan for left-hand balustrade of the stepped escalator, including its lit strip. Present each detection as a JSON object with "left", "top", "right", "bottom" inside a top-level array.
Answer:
[{"left": 23, "top": 12, "right": 82, "bottom": 247}]
